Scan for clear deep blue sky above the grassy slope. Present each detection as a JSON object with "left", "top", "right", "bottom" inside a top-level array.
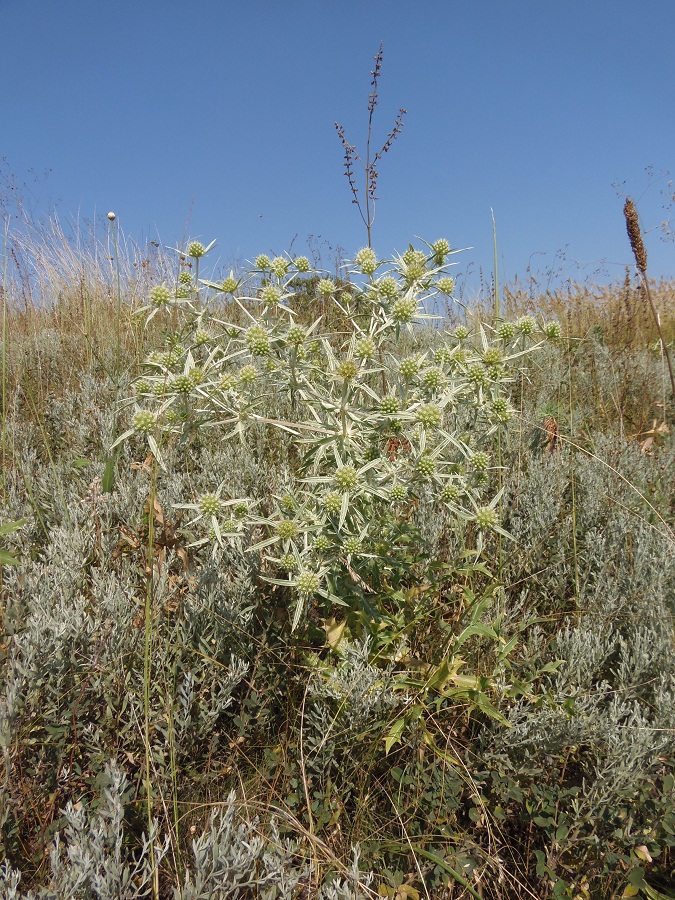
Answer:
[{"left": 0, "top": 0, "right": 675, "bottom": 296}]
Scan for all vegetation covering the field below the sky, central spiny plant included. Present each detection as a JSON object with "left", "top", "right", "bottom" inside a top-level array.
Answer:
[{"left": 0, "top": 54, "right": 675, "bottom": 900}]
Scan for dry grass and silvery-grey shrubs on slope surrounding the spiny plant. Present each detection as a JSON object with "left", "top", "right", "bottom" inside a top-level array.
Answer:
[{"left": 0, "top": 220, "right": 675, "bottom": 900}]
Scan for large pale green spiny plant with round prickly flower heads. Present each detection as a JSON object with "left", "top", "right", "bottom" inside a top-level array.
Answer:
[{"left": 118, "top": 239, "right": 558, "bottom": 630}]
